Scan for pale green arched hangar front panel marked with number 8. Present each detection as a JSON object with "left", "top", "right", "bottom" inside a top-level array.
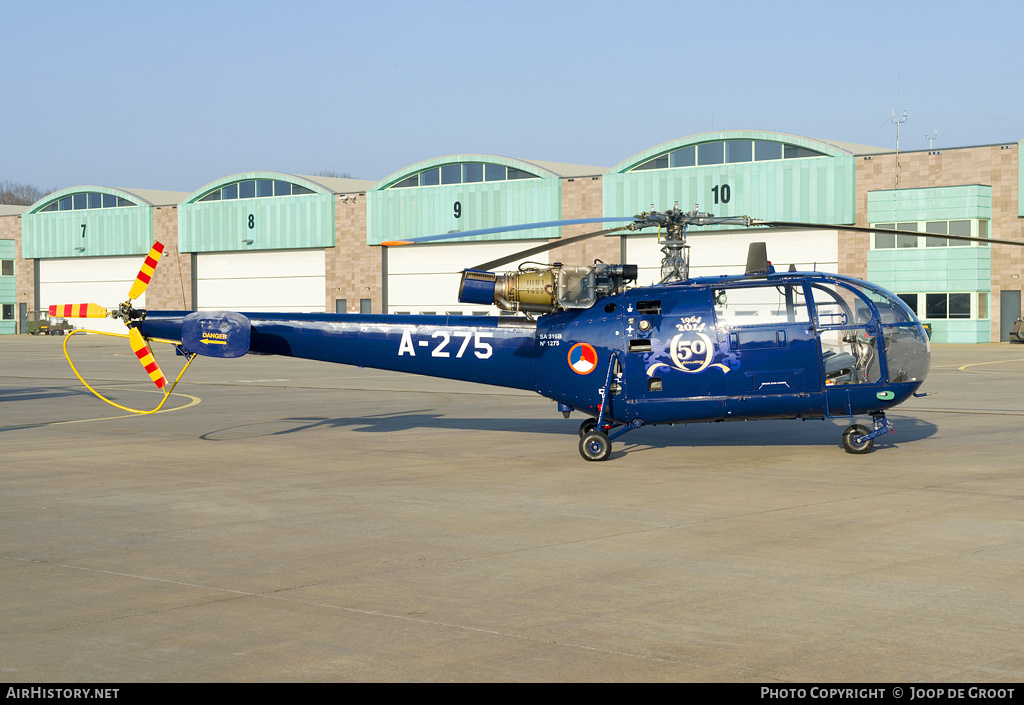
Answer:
[{"left": 178, "top": 172, "right": 335, "bottom": 252}]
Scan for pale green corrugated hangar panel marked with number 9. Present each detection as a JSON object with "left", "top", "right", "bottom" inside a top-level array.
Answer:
[{"left": 367, "top": 178, "right": 562, "bottom": 245}]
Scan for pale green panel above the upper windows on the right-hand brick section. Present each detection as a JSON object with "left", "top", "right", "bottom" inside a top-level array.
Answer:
[{"left": 867, "top": 184, "right": 992, "bottom": 222}]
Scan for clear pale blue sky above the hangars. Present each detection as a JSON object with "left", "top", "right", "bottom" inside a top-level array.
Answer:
[{"left": 0, "top": 0, "right": 1024, "bottom": 191}]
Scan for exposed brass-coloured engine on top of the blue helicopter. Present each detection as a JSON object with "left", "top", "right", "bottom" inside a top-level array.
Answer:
[{"left": 459, "top": 262, "right": 637, "bottom": 314}]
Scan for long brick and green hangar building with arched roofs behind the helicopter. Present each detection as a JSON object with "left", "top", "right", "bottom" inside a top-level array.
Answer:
[{"left": 0, "top": 130, "right": 1024, "bottom": 342}]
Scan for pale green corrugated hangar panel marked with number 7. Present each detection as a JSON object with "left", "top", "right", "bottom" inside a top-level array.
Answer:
[{"left": 22, "top": 203, "right": 154, "bottom": 259}]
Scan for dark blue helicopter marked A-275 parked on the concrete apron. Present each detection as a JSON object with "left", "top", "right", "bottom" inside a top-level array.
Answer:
[{"left": 51, "top": 207, "right": 999, "bottom": 461}]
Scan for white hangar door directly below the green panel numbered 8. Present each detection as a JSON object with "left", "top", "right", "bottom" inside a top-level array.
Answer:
[{"left": 196, "top": 249, "right": 327, "bottom": 313}]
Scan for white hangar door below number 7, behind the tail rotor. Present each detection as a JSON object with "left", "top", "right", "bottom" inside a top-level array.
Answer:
[{"left": 39, "top": 255, "right": 145, "bottom": 333}]
